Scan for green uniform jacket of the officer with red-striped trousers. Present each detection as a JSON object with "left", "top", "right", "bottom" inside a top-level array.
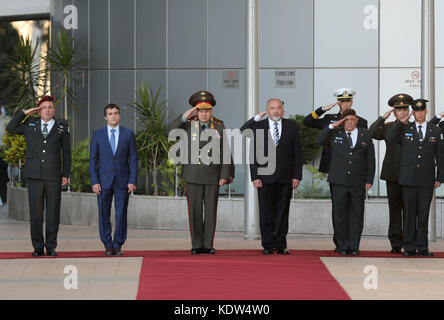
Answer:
[{"left": 167, "top": 116, "right": 234, "bottom": 185}]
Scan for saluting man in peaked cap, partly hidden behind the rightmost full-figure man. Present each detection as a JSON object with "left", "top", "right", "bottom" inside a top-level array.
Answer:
[{"left": 370, "top": 93, "right": 413, "bottom": 253}]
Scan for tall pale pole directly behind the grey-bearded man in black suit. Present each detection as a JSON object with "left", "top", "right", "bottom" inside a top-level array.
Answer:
[{"left": 244, "top": 0, "right": 260, "bottom": 240}]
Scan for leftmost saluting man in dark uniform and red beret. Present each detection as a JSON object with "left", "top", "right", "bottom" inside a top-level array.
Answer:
[{"left": 6, "top": 96, "right": 71, "bottom": 257}]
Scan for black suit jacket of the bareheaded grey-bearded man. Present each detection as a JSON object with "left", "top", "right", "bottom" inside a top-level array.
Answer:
[{"left": 241, "top": 117, "right": 303, "bottom": 184}]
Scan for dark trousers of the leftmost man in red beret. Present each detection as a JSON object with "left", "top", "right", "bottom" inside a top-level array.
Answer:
[{"left": 28, "top": 178, "right": 62, "bottom": 249}]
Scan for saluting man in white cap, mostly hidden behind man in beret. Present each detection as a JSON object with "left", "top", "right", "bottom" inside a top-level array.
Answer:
[{"left": 304, "top": 88, "right": 367, "bottom": 252}]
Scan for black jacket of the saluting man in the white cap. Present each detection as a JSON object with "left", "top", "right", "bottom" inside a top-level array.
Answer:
[{"left": 303, "top": 107, "right": 367, "bottom": 173}]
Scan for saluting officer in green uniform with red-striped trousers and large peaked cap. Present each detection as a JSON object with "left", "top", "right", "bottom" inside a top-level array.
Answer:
[{"left": 167, "top": 90, "right": 234, "bottom": 254}]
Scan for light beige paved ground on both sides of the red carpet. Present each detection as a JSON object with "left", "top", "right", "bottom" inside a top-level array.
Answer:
[{"left": 0, "top": 202, "right": 444, "bottom": 300}]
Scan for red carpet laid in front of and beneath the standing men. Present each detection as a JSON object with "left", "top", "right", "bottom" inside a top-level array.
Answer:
[{"left": 0, "top": 250, "right": 444, "bottom": 300}]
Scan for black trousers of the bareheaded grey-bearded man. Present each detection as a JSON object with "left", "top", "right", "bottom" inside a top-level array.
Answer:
[{"left": 257, "top": 182, "right": 292, "bottom": 249}]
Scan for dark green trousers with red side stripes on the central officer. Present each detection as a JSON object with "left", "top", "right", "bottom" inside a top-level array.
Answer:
[{"left": 186, "top": 183, "right": 219, "bottom": 249}]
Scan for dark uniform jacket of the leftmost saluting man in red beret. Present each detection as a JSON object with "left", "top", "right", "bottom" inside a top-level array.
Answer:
[{"left": 6, "top": 111, "right": 71, "bottom": 180}]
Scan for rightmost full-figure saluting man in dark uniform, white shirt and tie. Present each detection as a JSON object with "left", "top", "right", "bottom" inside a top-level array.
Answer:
[{"left": 387, "top": 99, "right": 444, "bottom": 256}]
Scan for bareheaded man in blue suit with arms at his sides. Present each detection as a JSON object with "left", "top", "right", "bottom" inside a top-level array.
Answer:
[{"left": 89, "top": 104, "right": 137, "bottom": 256}]
